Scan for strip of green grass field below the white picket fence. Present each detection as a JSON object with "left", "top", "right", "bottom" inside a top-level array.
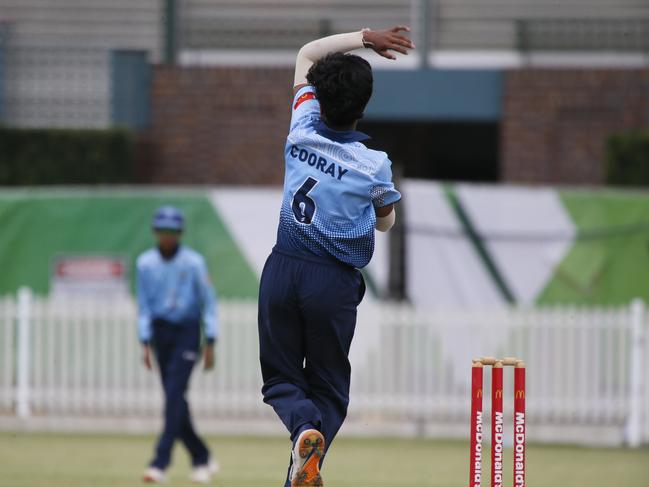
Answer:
[{"left": 0, "top": 433, "right": 649, "bottom": 487}]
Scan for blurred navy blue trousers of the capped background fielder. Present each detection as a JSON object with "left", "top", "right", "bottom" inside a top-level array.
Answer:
[{"left": 151, "top": 320, "right": 209, "bottom": 470}]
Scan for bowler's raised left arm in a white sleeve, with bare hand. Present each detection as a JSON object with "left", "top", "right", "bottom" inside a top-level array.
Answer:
[{"left": 293, "top": 25, "right": 415, "bottom": 94}]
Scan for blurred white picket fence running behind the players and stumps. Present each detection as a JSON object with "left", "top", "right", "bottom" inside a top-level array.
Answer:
[{"left": 0, "top": 290, "right": 649, "bottom": 446}]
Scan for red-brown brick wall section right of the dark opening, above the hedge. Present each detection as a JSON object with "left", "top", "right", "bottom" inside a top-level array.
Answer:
[{"left": 501, "top": 69, "right": 649, "bottom": 184}]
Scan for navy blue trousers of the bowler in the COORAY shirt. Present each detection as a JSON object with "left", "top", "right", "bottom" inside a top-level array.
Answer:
[{"left": 259, "top": 248, "right": 365, "bottom": 485}]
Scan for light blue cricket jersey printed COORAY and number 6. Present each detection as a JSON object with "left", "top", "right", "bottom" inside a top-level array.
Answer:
[{"left": 277, "top": 86, "right": 401, "bottom": 268}]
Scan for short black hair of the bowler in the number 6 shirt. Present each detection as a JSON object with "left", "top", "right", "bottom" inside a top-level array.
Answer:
[{"left": 306, "top": 52, "right": 373, "bottom": 127}]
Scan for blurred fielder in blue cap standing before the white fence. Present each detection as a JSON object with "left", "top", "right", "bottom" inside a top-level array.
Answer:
[{"left": 137, "top": 206, "right": 218, "bottom": 483}]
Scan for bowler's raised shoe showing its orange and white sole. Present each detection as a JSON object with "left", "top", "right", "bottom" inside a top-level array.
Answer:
[{"left": 290, "top": 430, "right": 324, "bottom": 487}]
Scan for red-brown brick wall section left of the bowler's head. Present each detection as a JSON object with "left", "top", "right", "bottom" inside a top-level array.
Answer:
[{"left": 145, "top": 66, "right": 293, "bottom": 184}]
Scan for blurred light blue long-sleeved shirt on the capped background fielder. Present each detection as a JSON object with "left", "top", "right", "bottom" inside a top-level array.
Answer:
[{"left": 136, "top": 245, "right": 218, "bottom": 342}]
